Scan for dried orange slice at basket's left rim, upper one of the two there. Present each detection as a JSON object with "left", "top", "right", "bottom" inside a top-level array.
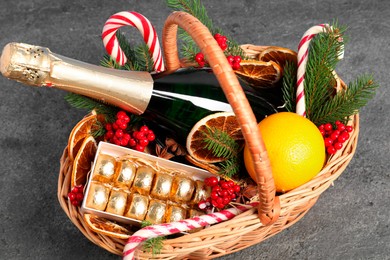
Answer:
[{"left": 68, "top": 112, "right": 97, "bottom": 160}]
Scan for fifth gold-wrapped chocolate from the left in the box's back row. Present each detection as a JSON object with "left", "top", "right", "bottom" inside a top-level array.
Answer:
[{"left": 170, "top": 175, "right": 195, "bottom": 203}]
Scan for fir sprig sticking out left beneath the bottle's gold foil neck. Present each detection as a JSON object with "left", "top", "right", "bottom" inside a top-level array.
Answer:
[{"left": 65, "top": 93, "right": 118, "bottom": 122}]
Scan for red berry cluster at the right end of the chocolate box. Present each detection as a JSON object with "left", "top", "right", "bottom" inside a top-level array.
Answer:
[{"left": 198, "top": 177, "right": 241, "bottom": 210}]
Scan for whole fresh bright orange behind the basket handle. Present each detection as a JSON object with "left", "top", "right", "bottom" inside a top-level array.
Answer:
[{"left": 244, "top": 112, "right": 326, "bottom": 192}]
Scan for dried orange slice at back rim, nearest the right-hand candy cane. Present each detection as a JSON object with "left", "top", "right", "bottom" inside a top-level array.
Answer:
[{"left": 259, "top": 46, "right": 297, "bottom": 69}]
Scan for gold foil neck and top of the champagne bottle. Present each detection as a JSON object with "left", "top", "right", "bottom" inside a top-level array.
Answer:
[{"left": 0, "top": 43, "right": 153, "bottom": 115}]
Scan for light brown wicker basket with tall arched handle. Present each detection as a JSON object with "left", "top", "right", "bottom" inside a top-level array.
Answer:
[{"left": 58, "top": 12, "right": 359, "bottom": 259}]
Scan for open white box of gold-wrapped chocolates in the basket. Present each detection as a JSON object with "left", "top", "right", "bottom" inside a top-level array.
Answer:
[{"left": 81, "top": 142, "right": 213, "bottom": 226}]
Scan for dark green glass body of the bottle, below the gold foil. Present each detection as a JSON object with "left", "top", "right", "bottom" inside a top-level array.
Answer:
[{"left": 145, "top": 69, "right": 277, "bottom": 141}]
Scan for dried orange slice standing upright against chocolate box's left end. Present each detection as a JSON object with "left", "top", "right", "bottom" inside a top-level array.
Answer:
[{"left": 71, "top": 136, "right": 97, "bottom": 187}]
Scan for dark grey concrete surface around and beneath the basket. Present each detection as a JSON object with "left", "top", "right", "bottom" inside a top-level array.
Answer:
[{"left": 0, "top": 0, "right": 390, "bottom": 260}]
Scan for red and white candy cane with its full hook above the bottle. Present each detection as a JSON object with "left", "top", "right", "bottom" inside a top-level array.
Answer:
[{"left": 102, "top": 11, "right": 165, "bottom": 71}]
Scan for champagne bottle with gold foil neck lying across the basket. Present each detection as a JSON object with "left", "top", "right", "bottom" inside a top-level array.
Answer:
[{"left": 0, "top": 43, "right": 276, "bottom": 141}]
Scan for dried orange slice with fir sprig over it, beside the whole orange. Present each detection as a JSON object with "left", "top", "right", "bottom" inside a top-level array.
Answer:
[{"left": 186, "top": 112, "right": 244, "bottom": 163}]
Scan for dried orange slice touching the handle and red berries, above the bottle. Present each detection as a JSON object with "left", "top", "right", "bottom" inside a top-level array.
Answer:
[{"left": 234, "top": 60, "right": 282, "bottom": 88}]
